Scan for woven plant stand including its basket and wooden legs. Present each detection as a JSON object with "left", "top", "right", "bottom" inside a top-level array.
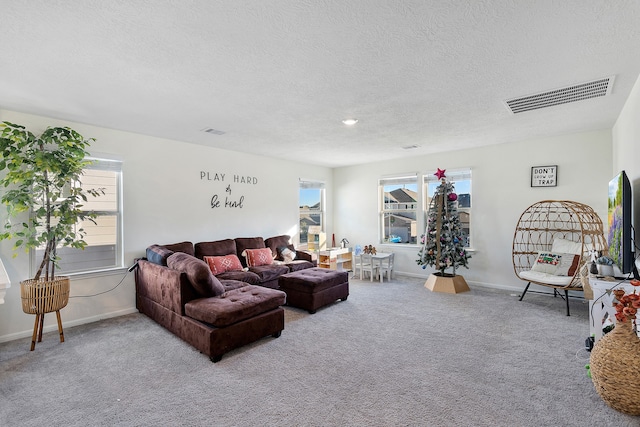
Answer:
[{"left": 20, "top": 276, "right": 70, "bottom": 351}]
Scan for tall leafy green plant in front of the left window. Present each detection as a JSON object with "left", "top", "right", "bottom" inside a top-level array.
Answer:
[{"left": 0, "top": 122, "right": 104, "bottom": 280}]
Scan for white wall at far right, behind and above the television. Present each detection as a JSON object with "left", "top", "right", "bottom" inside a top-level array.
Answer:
[{"left": 612, "top": 72, "right": 640, "bottom": 268}]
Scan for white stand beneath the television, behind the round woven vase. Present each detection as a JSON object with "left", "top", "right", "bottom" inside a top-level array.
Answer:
[{"left": 589, "top": 276, "right": 640, "bottom": 344}]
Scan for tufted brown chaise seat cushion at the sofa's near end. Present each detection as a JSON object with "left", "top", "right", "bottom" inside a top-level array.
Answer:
[{"left": 184, "top": 285, "right": 287, "bottom": 328}]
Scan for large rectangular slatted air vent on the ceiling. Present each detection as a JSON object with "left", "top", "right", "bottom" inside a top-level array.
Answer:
[{"left": 505, "top": 76, "right": 614, "bottom": 114}]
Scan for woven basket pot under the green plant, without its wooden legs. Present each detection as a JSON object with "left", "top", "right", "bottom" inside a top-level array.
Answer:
[{"left": 20, "top": 276, "right": 70, "bottom": 314}]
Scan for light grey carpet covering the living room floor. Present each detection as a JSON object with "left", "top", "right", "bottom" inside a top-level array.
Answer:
[{"left": 0, "top": 277, "right": 640, "bottom": 426}]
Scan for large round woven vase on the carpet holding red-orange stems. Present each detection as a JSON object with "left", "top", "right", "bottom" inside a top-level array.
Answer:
[{"left": 590, "top": 322, "right": 640, "bottom": 415}]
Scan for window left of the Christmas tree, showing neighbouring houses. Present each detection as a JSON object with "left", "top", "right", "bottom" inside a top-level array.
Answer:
[{"left": 378, "top": 175, "right": 418, "bottom": 243}]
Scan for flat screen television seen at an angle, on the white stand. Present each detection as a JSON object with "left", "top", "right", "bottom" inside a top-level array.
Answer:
[{"left": 607, "top": 171, "right": 639, "bottom": 279}]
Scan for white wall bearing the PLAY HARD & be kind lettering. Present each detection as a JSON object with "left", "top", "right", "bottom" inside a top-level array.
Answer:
[{"left": 0, "top": 110, "right": 333, "bottom": 341}]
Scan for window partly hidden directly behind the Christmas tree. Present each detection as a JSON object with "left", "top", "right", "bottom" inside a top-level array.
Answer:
[{"left": 424, "top": 169, "right": 471, "bottom": 248}]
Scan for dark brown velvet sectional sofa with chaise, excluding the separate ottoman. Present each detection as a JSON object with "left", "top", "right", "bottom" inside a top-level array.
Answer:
[{"left": 135, "top": 236, "right": 314, "bottom": 362}]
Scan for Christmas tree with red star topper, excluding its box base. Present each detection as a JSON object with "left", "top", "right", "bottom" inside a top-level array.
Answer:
[{"left": 416, "top": 168, "right": 471, "bottom": 276}]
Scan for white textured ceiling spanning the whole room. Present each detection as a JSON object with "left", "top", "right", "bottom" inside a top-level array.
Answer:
[{"left": 0, "top": 0, "right": 640, "bottom": 167}]
